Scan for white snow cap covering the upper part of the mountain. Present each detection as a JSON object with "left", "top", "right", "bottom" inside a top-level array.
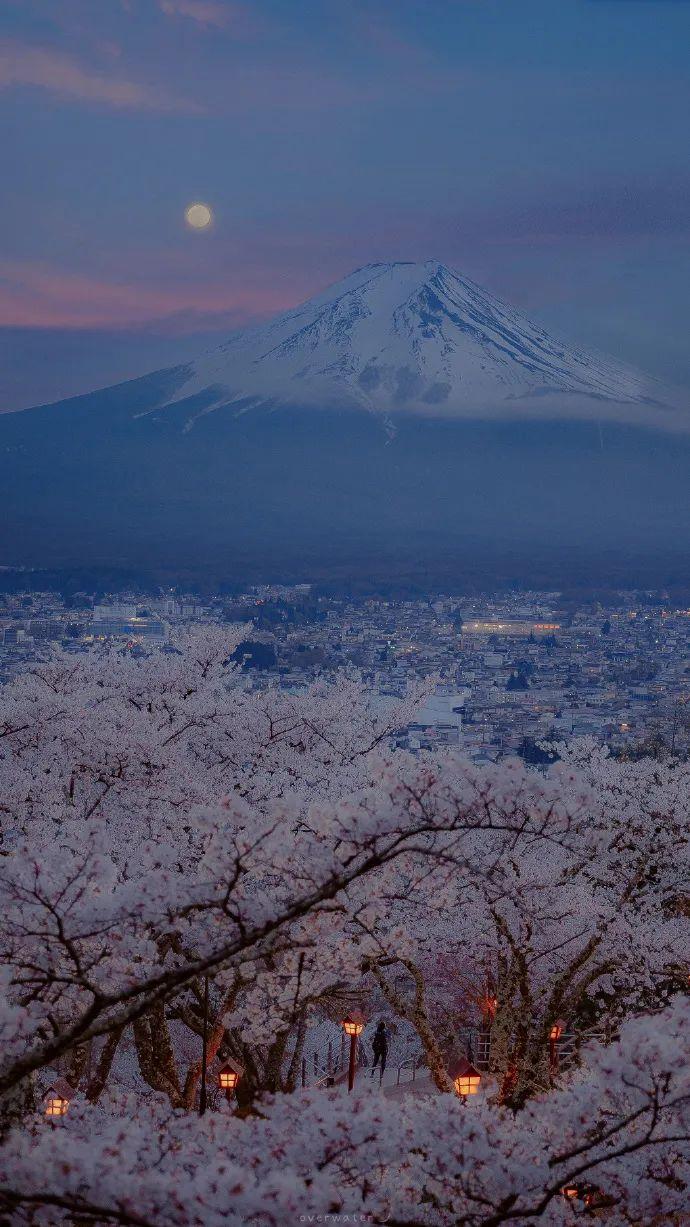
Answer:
[{"left": 166, "top": 260, "right": 662, "bottom": 420}]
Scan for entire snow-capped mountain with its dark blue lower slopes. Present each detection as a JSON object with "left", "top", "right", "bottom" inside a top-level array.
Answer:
[{"left": 0, "top": 261, "right": 690, "bottom": 585}]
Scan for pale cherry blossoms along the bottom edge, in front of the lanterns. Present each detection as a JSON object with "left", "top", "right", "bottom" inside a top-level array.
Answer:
[{"left": 0, "top": 1002, "right": 690, "bottom": 1227}]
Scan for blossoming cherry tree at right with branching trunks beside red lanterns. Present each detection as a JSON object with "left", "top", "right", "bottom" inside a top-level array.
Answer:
[{"left": 372, "top": 744, "right": 690, "bottom": 1106}]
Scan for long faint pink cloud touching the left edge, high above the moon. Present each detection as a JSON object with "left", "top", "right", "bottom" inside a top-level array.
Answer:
[{"left": 0, "top": 40, "right": 203, "bottom": 112}]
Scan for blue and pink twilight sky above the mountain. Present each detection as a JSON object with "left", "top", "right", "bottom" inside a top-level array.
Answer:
[{"left": 0, "top": 0, "right": 690, "bottom": 409}]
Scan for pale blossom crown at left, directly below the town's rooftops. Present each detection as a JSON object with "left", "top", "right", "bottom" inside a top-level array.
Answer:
[{"left": 0, "top": 626, "right": 432, "bottom": 844}]
